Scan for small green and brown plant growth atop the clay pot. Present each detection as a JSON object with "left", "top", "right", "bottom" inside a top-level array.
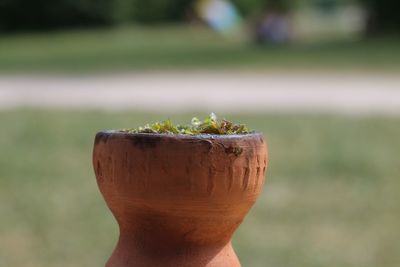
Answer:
[{"left": 121, "top": 113, "right": 253, "bottom": 135}]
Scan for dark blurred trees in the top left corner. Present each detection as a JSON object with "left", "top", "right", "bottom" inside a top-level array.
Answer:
[{"left": 0, "top": 0, "right": 194, "bottom": 31}]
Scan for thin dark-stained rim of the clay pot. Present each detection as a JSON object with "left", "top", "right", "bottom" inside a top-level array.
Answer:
[{"left": 96, "top": 130, "right": 264, "bottom": 140}]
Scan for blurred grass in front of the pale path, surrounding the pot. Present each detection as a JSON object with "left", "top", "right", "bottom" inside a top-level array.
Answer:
[{"left": 0, "top": 110, "right": 400, "bottom": 267}]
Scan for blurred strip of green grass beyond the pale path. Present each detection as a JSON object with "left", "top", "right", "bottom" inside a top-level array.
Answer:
[{"left": 0, "top": 26, "right": 400, "bottom": 73}]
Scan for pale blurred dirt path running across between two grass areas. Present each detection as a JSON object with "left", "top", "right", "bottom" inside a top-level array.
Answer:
[{"left": 0, "top": 73, "right": 400, "bottom": 115}]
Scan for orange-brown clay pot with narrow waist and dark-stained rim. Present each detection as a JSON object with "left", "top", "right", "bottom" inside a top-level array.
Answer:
[{"left": 93, "top": 131, "right": 267, "bottom": 267}]
